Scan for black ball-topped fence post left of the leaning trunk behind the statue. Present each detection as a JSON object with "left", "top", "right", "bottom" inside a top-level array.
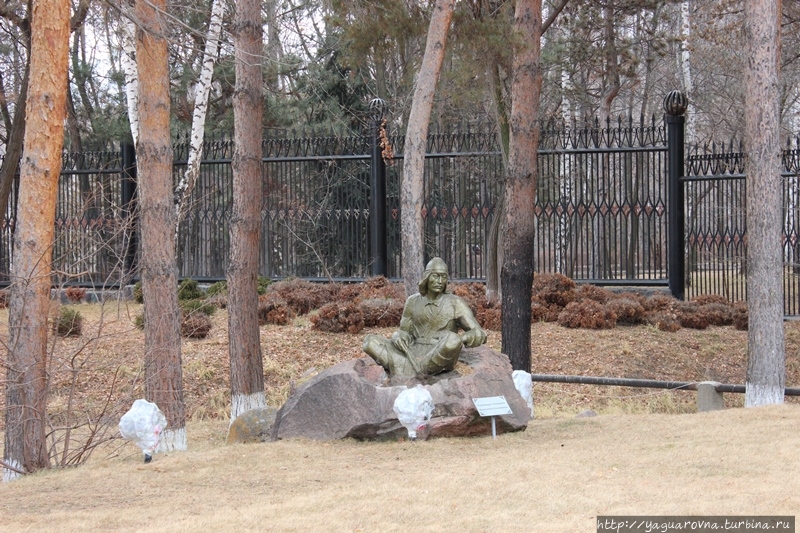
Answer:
[{"left": 369, "top": 98, "right": 388, "bottom": 276}]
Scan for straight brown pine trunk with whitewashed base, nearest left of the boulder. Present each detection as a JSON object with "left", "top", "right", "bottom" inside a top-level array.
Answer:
[{"left": 228, "top": 0, "right": 266, "bottom": 422}]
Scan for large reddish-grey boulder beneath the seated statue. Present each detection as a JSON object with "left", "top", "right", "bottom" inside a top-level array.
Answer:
[{"left": 272, "top": 346, "right": 530, "bottom": 440}]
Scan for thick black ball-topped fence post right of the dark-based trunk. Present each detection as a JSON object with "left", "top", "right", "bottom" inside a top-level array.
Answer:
[{"left": 664, "top": 91, "right": 688, "bottom": 300}]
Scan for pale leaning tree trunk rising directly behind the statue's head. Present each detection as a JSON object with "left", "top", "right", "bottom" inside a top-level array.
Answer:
[{"left": 400, "top": 0, "right": 455, "bottom": 295}]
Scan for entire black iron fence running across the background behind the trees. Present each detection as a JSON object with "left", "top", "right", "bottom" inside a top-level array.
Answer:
[{"left": 0, "top": 91, "right": 800, "bottom": 315}]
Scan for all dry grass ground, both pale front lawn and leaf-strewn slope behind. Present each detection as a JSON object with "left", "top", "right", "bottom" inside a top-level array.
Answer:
[{"left": 0, "top": 303, "right": 800, "bottom": 532}]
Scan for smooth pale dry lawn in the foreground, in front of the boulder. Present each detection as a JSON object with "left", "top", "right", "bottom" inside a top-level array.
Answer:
[{"left": 0, "top": 406, "right": 800, "bottom": 532}]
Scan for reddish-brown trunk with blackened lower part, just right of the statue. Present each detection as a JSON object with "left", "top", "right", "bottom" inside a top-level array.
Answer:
[{"left": 501, "top": 0, "right": 542, "bottom": 372}]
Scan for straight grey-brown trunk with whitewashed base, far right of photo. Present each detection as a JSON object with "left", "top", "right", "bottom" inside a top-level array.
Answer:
[{"left": 744, "top": 0, "right": 786, "bottom": 407}]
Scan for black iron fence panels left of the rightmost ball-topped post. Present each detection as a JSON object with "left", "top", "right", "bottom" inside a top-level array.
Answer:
[{"left": 0, "top": 111, "right": 680, "bottom": 286}]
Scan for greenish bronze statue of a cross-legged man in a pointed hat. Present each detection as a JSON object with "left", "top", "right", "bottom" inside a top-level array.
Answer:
[{"left": 362, "top": 257, "right": 486, "bottom": 378}]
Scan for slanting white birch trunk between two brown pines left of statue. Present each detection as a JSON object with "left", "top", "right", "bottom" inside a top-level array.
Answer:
[{"left": 175, "top": 0, "right": 225, "bottom": 229}]
